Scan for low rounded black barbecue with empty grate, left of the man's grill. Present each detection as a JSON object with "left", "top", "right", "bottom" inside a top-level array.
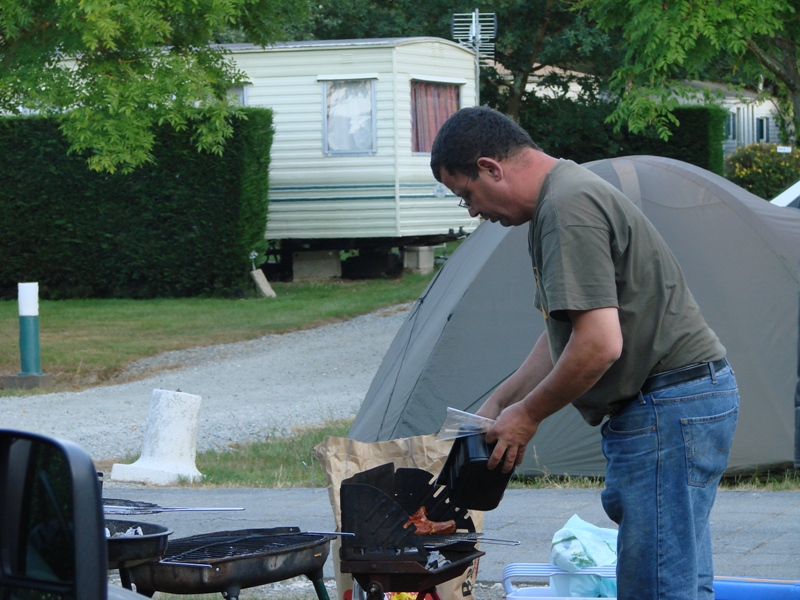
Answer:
[{"left": 128, "top": 527, "right": 333, "bottom": 600}]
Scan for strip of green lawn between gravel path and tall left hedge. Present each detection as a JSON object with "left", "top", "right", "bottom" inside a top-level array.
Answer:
[{"left": 0, "top": 273, "right": 432, "bottom": 396}]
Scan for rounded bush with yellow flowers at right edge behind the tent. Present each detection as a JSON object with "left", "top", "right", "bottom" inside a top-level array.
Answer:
[{"left": 725, "top": 144, "right": 800, "bottom": 200}]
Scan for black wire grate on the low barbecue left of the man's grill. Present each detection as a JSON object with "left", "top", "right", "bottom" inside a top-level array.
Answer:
[{"left": 161, "top": 531, "right": 325, "bottom": 563}]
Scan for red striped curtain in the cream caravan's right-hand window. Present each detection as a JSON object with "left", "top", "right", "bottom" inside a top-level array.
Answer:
[{"left": 411, "top": 81, "right": 458, "bottom": 152}]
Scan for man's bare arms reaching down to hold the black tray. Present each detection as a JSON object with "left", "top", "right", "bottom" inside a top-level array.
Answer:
[{"left": 479, "top": 307, "right": 622, "bottom": 472}]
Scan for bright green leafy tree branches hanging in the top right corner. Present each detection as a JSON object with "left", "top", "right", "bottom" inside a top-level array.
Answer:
[{"left": 577, "top": 0, "right": 800, "bottom": 139}]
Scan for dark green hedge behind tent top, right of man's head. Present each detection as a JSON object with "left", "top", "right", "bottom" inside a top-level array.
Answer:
[{"left": 520, "top": 96, "right": 727, "bottom": 175}]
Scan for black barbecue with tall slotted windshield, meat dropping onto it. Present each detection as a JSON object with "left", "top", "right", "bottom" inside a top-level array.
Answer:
[{"left": 339, "top": 463, "right": 485, "bottom": 600}]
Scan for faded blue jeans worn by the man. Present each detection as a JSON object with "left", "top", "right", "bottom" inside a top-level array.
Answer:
[{"left": 601, "top": 366, "right": 739, "bottom": 600}]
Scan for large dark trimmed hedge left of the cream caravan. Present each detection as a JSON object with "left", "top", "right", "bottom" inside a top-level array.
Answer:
[{"left": 0, "top": 109, "right": 273, "bottom": 299}]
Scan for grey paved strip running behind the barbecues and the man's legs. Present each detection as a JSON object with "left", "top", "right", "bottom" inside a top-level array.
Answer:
[{"left": 104, "top": 482, "right": 800, "bottom": 582}]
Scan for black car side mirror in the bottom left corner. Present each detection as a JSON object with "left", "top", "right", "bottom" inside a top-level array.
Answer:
[{"left": 0, "top": 430, "right": 108, "bottom": 600}]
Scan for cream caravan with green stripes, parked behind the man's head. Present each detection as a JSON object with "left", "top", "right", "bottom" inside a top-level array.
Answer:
[{"left": 225, "top": 37, "right": 478, "bottom": 278}]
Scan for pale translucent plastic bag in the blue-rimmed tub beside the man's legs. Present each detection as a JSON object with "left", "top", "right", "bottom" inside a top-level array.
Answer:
[{"left": 550, "top": 515, "right": 617, "bottom": 598}]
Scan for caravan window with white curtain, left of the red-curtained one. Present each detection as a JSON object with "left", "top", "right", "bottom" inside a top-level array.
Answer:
[{"left": 322, "top": 79, "right": 378, "bottom": 156}]
